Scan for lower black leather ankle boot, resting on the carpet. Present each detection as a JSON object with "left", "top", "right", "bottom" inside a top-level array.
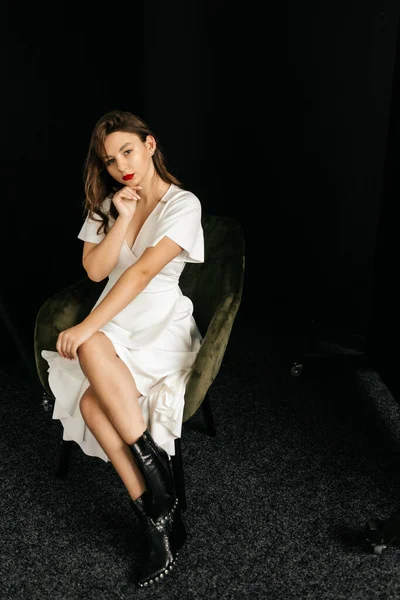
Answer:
[{"left": 131, "top": 492, "right": 185, "bottom": 587}]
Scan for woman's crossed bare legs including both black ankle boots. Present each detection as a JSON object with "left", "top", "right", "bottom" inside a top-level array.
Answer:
[{"left": 78, "top": 332, "right": 186, "bottom": 586}]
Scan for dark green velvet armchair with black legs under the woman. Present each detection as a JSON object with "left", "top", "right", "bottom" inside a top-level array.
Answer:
[{"left": 34, "top": 215, "right": 245, "bottom": 508}]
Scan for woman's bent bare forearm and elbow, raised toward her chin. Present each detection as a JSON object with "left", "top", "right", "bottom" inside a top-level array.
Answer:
[{"left": 82, "top": 215, "right": 130, "bottom": 281}]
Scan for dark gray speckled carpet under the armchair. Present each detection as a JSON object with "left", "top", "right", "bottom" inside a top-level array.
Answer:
[{"left": 0, "top": 323, "right": 400, "bottom": 600}]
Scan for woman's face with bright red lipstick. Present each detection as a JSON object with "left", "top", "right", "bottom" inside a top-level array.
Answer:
[{"left": 103, "top": 131, "right": 156, "bottom": 186}]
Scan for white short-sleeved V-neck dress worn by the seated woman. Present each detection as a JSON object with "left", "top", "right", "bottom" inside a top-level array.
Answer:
[{"left": 42, "top": 184, "right": 204, "bottom": 462}]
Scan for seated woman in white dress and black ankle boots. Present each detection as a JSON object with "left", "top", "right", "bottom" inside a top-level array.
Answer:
[{"left": 42, "top": 110, "right": 204, "bottom": 586}]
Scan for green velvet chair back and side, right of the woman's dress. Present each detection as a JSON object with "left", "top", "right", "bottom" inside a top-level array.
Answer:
[{"left": 180, "top": 215, "right": 245, "bottom": 421}]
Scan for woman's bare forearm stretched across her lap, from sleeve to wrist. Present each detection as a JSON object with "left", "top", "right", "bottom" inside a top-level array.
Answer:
[{"left": 82, "top": 234, "right": 182, "bottom": 331}]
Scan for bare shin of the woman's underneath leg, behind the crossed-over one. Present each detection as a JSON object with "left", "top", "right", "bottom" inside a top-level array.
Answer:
[{"left": 80, "top": 386, "right": 146, "bottom": 500}]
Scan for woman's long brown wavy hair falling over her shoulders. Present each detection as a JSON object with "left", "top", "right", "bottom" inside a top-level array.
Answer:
[{"left": 83, "top": 110, "right": 182, "bottom": 233}]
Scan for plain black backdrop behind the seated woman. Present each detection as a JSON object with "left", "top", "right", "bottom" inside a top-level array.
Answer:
[{"left": 0, "top": 0, "right": 399, "bottom": 398}]
